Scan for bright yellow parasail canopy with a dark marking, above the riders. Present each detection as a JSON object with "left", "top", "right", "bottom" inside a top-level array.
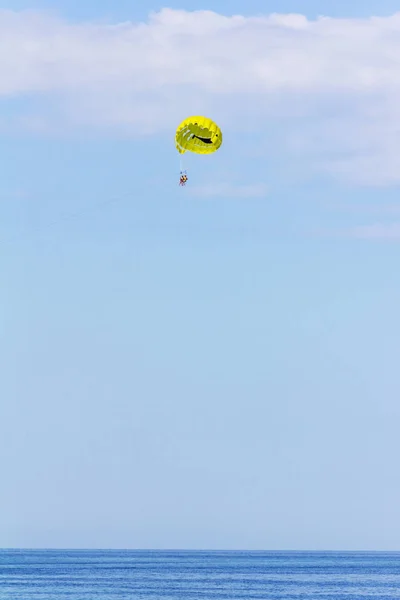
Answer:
[{"left": 175, "top": 117, "right": 222, "bottom": 154}]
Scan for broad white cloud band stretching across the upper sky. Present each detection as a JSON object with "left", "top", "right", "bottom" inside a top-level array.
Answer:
[{"left": 0, "top": 9, "right": 400, "bottom": 184}]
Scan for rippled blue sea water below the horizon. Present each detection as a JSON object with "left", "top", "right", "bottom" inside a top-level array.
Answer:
[{"left": 0, "top": 550, "right": 400, "bottom": 600}]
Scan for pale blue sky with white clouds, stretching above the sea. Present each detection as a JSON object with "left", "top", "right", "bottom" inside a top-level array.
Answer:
[{"left": 0, "top": 0, "right": 400, "bottom": 549}]
